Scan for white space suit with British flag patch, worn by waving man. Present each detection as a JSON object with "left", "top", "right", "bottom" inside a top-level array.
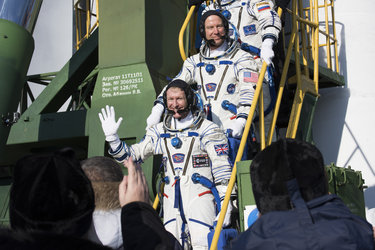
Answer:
[{"left": 110, "top": 112, "right": 231, "bottom": 249}]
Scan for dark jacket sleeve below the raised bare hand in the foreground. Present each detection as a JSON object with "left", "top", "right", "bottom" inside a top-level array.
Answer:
[{"left": 121, "top": 202, "right": 182, "bottom": 250}]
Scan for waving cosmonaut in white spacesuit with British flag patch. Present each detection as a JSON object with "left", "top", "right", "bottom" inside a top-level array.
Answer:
[{"left": 99, "top": 80, "right": 232, "bottom": 249}]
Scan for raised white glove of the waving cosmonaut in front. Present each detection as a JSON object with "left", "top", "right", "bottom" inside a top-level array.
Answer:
[{"left": 99, "top": 105, "right": 122, "bottom": 143}]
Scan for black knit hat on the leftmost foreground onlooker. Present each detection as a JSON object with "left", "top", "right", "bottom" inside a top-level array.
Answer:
[{"left": 9, "top": 149, "right": 95, "bottom": 237}]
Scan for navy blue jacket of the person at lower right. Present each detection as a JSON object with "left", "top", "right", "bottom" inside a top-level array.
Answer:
[{"left": 230, "top": 195, "right": 374, "bottom": 250}]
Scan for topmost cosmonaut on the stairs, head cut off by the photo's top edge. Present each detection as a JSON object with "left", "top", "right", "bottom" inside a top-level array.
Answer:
[{"left": 201, "top": 0, "right": 282, "bottom": 139}]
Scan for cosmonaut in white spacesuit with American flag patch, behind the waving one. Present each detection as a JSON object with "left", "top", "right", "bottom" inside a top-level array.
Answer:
[{"left": 147, "top": 10, "right": 261, "bottom": 161}]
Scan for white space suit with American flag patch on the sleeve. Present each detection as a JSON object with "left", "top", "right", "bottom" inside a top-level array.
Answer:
[{"left": 158, "top": 40, "right": 261, "bottom": 137}]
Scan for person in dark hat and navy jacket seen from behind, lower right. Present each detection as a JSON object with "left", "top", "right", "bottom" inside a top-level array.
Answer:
[{"left": 229, "top": 139, "right": 375, "bottom": 250}]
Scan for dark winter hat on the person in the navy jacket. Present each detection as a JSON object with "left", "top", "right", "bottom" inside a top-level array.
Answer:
[{"left": 250, "top": 139, "right": 328, "bottom": 214}]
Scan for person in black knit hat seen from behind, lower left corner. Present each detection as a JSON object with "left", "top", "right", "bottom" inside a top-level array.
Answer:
[{"left": 0, "top": 148, "right": 109, "bottom": 249}]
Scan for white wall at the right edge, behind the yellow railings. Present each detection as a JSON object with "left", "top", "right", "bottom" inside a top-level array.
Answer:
[{"left": 313, "top": 0, "right": 375, "bottom": 208}]
